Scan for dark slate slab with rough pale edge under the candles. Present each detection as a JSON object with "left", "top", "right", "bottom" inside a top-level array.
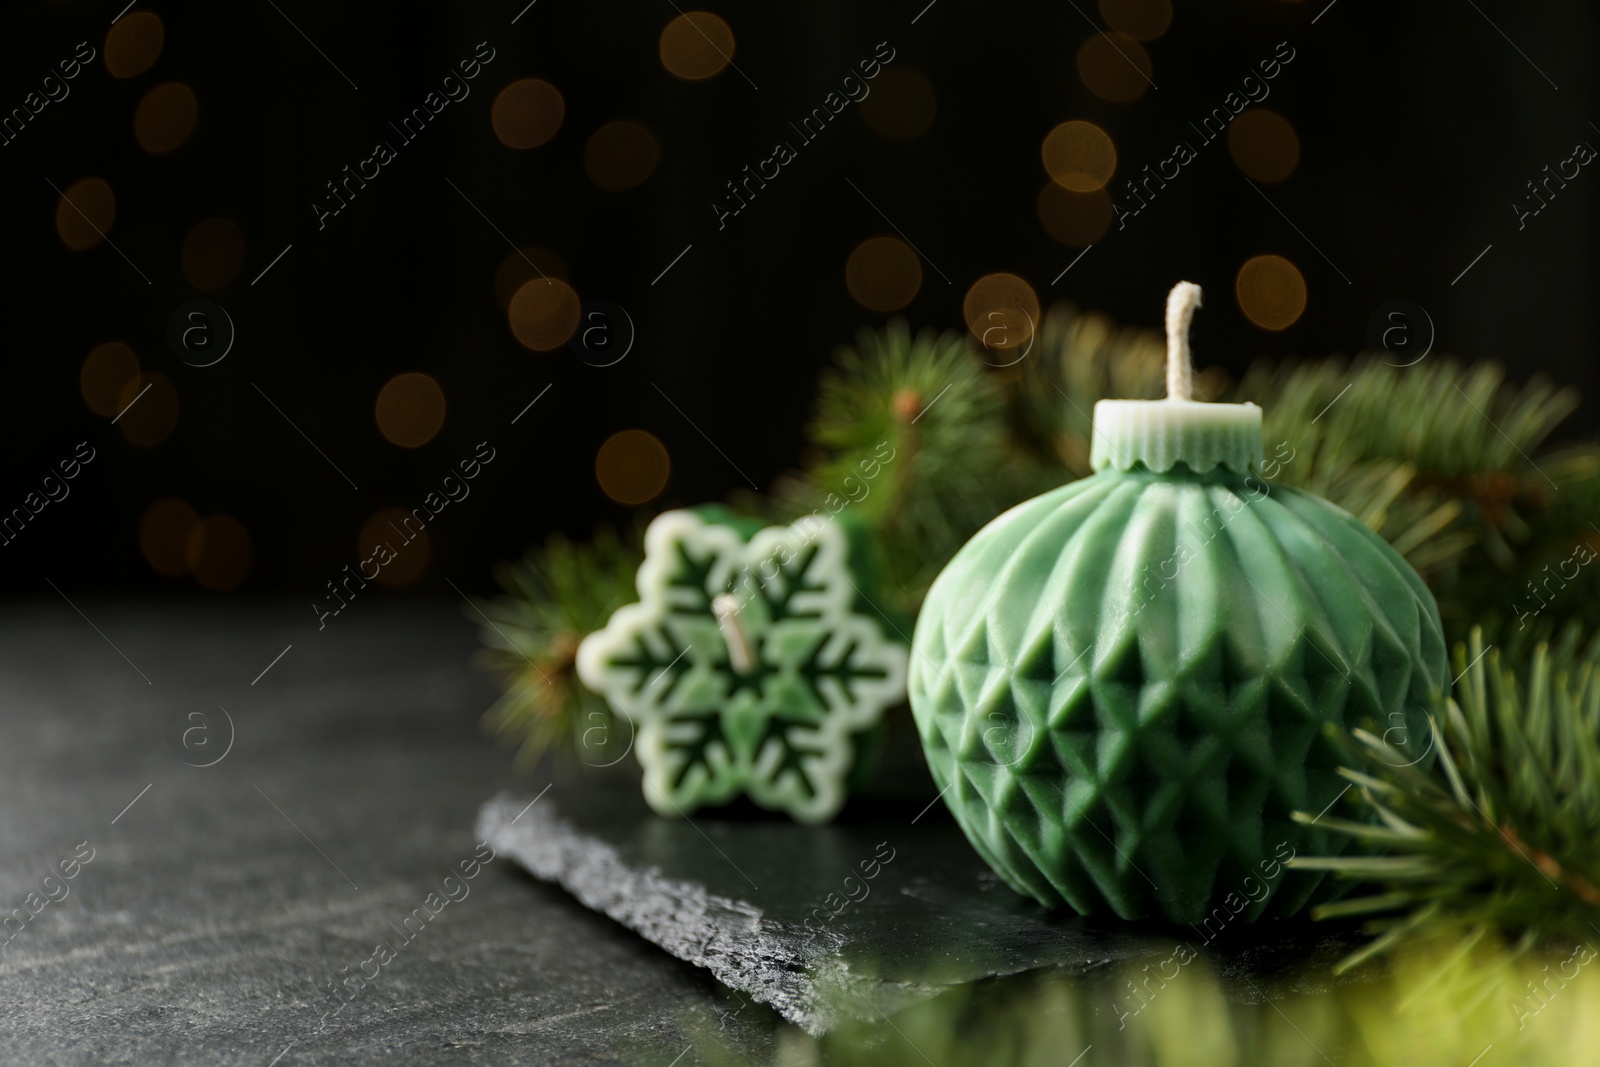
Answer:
[{"left": 477, "top": 768, "right": 1354, "bottom": 1035}]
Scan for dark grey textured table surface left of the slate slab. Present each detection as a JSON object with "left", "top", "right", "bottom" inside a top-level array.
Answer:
[{"left": 0, "top": 600, "right": 774, "bottom": 1067}]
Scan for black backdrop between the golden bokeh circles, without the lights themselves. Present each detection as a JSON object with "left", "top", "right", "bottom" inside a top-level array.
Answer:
[{"left": 0, "top": 0, "right": 1600, "bottom": 600}]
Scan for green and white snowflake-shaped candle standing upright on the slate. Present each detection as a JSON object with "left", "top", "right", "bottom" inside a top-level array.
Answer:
[{"left": 578, "top": 509, "right": 907, "bottom": 822}]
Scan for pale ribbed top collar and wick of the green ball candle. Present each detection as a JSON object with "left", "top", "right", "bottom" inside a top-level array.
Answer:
[{"left": 1090, "top": 282, "right": 1261, "bottom": 474}]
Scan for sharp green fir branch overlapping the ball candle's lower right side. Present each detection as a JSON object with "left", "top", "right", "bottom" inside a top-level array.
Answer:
[{"left": 1290, "top": 627, "right": 1600, "bottom": 969}]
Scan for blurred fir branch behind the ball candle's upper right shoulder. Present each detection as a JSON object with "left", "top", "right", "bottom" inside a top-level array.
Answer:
[{"left": 1232, "top": 355, "right": 1600, "bottom": 648}]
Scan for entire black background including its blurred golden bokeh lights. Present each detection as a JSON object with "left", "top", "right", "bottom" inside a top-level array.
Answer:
[{"left": 0, "top": 0, "right": 1600, "bottom": 601}]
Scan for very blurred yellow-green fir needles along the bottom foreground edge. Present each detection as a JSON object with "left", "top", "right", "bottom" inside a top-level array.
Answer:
[{"left": 619, "top": 931, "right": 1600, "bottom": 1067}]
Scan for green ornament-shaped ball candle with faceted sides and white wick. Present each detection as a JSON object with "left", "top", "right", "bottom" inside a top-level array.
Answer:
[{"left": 907, "top": 282, "right": 1448, "bottom": 929}]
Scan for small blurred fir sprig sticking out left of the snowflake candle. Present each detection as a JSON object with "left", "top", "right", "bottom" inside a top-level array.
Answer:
[{"left": 474, "top": 528, "right": 643, "bottom": 768}]
